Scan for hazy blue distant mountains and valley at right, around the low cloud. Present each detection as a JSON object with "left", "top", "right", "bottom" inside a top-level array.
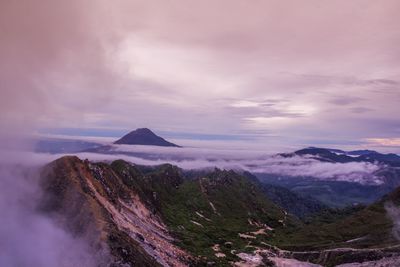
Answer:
[{"left": 254, "top": 147, "right": 400, "bottom": 209}]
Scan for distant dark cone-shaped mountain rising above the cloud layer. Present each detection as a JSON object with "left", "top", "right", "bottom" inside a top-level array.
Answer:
[{"left": 114, "top": 128, "right": 179, "bottom": 147}]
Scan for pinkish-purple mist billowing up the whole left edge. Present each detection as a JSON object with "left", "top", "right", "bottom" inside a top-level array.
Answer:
[{"left": 0, "top": 0, "right": 119, "bottom": 267}]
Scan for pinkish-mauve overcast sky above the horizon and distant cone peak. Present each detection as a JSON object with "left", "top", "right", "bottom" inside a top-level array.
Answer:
[{"left": 0, "top": 0, "right": 400, "bottom": 153}]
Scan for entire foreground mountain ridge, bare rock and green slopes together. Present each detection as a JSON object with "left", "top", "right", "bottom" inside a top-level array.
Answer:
[{"left": 41, "top": 156, "right": 400, "bottom": 267}]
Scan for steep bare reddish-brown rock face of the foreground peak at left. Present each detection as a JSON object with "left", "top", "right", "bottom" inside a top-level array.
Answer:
[{"left": 40, "top": 157, "right": 190, "bottom": 266}]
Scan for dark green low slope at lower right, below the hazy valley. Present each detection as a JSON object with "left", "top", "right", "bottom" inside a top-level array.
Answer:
[{"left": 274, "top": 202, "right": 397, "bottom": 250}]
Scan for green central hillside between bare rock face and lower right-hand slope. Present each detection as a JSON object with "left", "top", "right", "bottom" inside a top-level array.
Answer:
[{"left": 111, "top": 161, "right": 299, "bottom": 266}]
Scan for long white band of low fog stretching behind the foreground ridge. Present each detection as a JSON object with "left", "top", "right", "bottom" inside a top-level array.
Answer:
[{"left": 28, "top": 136, "right": 382, "bottom": 184}]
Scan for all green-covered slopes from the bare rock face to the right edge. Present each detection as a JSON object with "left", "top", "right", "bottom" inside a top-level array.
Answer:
[{"left": 111, "top": 161, "right": 400, "bottom": 266}]
